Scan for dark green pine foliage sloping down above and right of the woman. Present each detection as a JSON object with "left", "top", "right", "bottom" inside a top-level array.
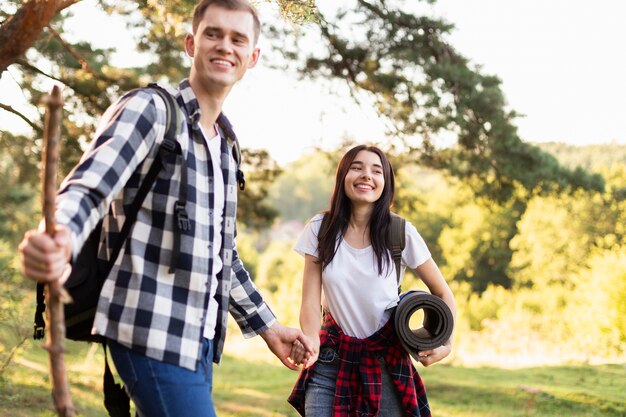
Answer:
[{"left": 283, "top": 0, "right": 603, "bottom": 202}]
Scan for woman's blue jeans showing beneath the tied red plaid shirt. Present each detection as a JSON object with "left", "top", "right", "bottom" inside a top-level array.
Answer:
[{"left": 304, "top": 347, "right": 404, "bottom": 417}]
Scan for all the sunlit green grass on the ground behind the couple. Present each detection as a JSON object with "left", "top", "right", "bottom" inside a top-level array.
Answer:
[{"left": 0, "top": 336, "right": 626, "bottom": 417}]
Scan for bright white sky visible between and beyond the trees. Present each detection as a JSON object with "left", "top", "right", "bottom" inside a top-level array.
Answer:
[{"left": 0, "top": 0, "right": 626, "bottom": 164}]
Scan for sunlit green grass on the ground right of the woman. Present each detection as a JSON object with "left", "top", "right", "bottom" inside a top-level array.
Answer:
[{"left": 420, "top": 365, "right": 626, "bottom": 417}]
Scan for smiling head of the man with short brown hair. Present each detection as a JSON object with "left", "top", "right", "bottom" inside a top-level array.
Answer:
[{"left": 185, "top": 5, "right": 259, "bottom": 90}]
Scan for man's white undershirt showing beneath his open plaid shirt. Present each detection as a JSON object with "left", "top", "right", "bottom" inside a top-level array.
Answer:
[{"left": 200, "top": 127, "right": 224, "bottom": 339}]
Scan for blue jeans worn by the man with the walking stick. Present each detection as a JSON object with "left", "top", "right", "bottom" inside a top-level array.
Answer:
[{"left": 107, "top": 339, "right": 216, "bottom": 417}]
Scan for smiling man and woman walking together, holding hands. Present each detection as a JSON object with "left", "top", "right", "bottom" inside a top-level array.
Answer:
[{"left": 19, "top": 0, "right": 454, "bottom": 417}]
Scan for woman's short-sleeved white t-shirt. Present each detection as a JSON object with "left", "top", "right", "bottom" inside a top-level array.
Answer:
[{"left": 295, "top": 214, "right": 431, "bottom": 339}]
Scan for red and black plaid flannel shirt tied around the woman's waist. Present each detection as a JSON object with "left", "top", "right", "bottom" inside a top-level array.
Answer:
[{"left": 288, "top": 313, "right": 431, "bottom": 417}]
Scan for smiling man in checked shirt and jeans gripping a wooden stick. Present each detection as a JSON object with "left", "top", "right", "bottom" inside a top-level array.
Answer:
[{"left": 20, "top": 0, "right": 311, "bottom": 417}]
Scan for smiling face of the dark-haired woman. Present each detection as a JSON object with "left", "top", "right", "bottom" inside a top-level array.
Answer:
[{"left": 343, "top": 150, "right": 385, "bottom": 205}]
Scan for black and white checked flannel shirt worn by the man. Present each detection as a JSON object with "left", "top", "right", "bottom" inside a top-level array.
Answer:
[{"left": 56, "top": 80, "right": 275, "bottom": 370}]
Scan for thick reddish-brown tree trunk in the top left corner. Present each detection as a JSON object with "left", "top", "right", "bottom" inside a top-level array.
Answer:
[{"left": 0, "top": 0, "right": 80, "bottom": 75}]
